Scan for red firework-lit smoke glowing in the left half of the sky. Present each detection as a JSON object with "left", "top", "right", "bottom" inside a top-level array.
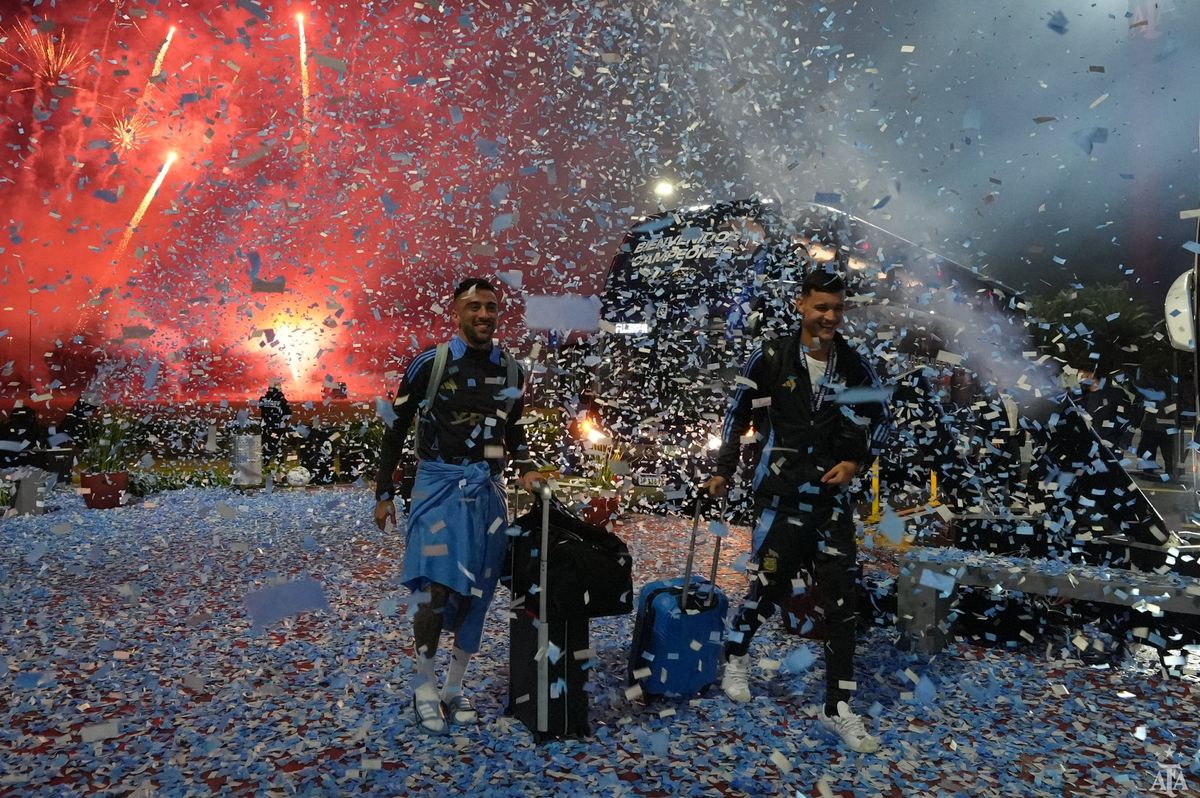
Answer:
[{"left": 0, "top": 1, "right": 620, "bottom": 397}]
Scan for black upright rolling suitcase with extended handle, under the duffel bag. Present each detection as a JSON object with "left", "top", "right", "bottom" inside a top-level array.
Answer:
[{"left": 508, "top": 490, "right": 595, "bottom": 743}]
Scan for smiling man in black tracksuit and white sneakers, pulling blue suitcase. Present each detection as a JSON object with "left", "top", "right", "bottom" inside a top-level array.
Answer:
[{"left": 704, "top": 264, "right": 888, "bottom": 752}]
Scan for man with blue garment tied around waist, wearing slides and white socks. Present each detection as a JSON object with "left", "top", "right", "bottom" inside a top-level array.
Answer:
[{"left": 374, "top": 277, "right": 539, "bottom": 733}]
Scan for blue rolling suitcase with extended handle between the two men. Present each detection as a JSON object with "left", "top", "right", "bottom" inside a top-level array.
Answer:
[{"left": 629, "top": 497, "right": 730, "bottom": 698}]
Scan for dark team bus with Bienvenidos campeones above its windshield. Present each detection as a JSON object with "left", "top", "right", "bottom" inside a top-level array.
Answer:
[{"left": 580, "top": 198, "right": 1169, "bottom": 568}]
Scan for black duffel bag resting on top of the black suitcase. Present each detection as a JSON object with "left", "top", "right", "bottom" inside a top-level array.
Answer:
[{"left": 503, "top": 498, "right": 634, "bottom": 618}]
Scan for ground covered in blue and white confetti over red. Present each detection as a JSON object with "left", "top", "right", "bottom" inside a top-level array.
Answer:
[{"left": 0, "top": 488, "right": 1200, "bottom": 796}]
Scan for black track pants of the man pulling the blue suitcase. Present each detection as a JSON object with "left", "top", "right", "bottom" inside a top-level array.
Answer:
[{"left": 725, "top": 506, "right": 858, "bottom": 706}]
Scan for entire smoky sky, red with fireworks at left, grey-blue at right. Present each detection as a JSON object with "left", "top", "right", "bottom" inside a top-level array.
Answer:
[{"left": 0, "top": 0, "right": 1200, "bottom": 402}]
